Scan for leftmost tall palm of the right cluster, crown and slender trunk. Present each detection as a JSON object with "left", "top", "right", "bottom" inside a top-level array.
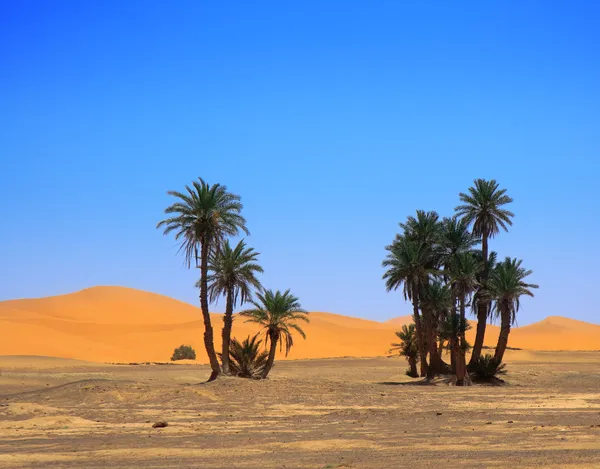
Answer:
[{"left": 382, "top": 235, "right": 432, "bottom": 376}]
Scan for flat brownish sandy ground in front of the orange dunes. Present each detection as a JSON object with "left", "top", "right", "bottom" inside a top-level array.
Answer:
[{"left": 0, "top": 351, "right": 600, "bottom": 469}]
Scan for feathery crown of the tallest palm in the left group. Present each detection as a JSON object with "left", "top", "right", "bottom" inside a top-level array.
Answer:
[{"left": 157, "top": 178, "right": 249, "bottom": 267}]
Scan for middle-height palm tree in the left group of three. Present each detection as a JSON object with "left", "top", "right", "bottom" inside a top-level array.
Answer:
[{"left": 196, "top": 240, "right": 263, "bottom": 374}]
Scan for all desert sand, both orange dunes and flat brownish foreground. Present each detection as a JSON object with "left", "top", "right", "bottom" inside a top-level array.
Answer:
[{"left": 0, "top": 287, "right": 600, "bottom": 469}]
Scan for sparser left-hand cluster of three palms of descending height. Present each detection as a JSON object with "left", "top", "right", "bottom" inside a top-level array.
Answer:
[{"left": 157, "top": 178, "right": 309, "bottom": 381}]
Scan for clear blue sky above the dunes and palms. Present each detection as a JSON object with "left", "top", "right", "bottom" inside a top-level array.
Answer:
[{"left": 0, "top": 0, "right": 600, "bottom": 324}]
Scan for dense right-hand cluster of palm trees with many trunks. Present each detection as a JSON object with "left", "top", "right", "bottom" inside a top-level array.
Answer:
[{"left": 383, "top": 179, "right": 537, "bottom": 385}]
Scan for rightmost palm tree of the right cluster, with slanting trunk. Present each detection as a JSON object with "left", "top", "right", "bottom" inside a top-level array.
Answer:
[{"left": 489, "top": 257, "right": 538, "bottom": 363}]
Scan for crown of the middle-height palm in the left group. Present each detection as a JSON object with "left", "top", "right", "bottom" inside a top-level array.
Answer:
[{"left": 203, "top": 240, "right": 263, "bottom": 307}]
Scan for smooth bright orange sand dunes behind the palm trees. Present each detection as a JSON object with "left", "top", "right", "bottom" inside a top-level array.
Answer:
[{"left": 0, "top": 287, "right": 600, "bottom": 362}]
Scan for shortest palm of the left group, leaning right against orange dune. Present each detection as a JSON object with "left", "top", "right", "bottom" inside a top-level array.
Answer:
[{"left": 240, "top": 289, "right": 310, "bottom": 378}]
